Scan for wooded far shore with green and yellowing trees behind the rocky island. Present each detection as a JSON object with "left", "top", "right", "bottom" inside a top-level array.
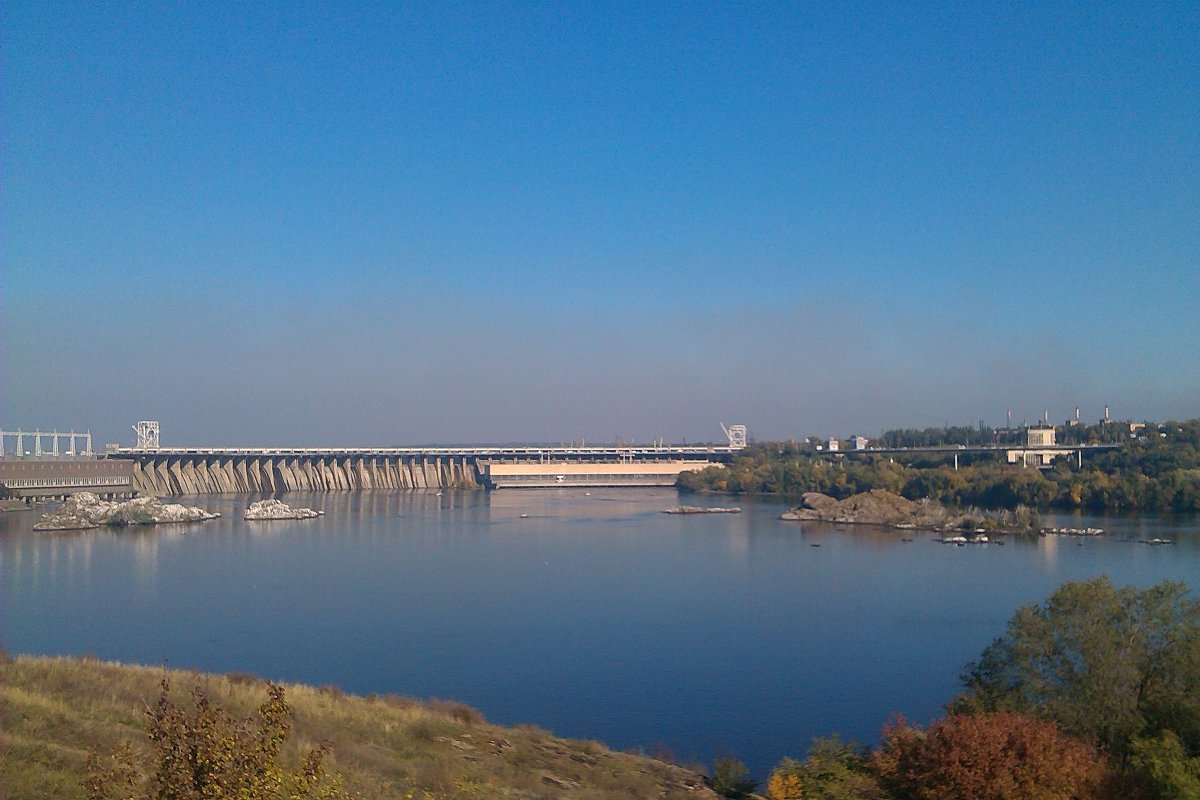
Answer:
[{"left": 678, "top": 420, "right": 1200, "bottom": 511}]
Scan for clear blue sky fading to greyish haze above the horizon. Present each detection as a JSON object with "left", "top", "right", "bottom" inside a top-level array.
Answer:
[{"left": 0, "top": 0, "right": 1200, "bottom": 446}]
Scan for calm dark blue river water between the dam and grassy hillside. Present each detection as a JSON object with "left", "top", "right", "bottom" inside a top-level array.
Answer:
[{"left": 0, "top": 489, "right": 1200, "bottom": 776}]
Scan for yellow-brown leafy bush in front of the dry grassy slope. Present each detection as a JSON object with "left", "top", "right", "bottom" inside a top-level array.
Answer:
[{"left": 84, "top": 679, "right": 346, "bottom": 800}]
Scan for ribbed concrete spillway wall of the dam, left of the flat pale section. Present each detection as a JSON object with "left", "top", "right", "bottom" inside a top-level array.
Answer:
[{"left": 125, "top": 456, "right": 480, "bottom": 495}]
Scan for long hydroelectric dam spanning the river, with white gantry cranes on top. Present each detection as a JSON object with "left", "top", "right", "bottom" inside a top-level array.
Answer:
[{"left": 106, "top": 422, "right": 746, "bottom": 495}]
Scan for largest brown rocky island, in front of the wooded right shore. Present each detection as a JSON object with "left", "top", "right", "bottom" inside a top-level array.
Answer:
[{"left": 780, "top": 489, "right": 1038, "bottom": 534}]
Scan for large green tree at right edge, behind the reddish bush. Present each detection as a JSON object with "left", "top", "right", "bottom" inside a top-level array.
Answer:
[{"left": 952, "top": 577, "right": 1200, "bottom": 760}]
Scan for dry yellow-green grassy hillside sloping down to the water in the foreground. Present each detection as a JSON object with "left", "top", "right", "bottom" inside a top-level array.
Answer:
[{"left": 0, "top": 656, "right": 715, "bottom": 800}]
